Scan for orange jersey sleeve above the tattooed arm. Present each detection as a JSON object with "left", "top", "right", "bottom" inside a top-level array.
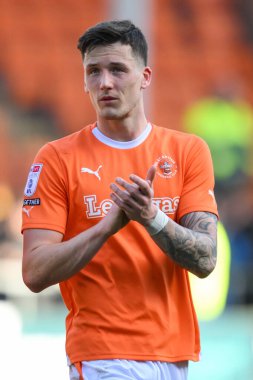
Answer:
[{"left": 178, "top": 135, "right": 218, "bottom": 220}]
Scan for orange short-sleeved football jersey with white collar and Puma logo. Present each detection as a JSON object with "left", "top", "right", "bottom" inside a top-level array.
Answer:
[{"left": 22, "top": 125, "right": 217, "bottom": 363}]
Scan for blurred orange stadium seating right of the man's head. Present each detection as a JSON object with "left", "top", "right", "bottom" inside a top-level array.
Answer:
[{"left": 151, "top": 0, "right": 253, "bottom": 127}]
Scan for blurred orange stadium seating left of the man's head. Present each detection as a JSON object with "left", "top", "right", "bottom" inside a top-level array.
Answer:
[{"left": 0, "top": 0, "right": 106, "bottom": 130}]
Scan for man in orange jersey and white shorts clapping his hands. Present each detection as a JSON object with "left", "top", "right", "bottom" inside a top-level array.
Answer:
[{"left": 23, "top": 21, "right": 217, "bottom": 380}]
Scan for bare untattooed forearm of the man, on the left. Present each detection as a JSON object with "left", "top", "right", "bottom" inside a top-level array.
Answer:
[{"left": 23, "top": 222, "right": 110, "bottom": 292}]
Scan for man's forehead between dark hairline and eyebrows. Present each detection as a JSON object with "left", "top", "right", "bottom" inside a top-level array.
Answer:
[{"left": 84, "top": 42, "right": 138, "bottom": 66}]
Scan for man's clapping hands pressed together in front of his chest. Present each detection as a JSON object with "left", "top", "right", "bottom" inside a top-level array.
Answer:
[{"left": 110, "top": 166, "right": 157, "bottom": 226}]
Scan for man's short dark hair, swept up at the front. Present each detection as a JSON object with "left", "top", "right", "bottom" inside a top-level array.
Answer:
[{"left": 77, "top": 20, "right": 148, "bottom": 66}]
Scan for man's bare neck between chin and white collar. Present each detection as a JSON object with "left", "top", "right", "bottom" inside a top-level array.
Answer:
[{"left": 97, "top": 115, "right": 148, "bottom": 141}]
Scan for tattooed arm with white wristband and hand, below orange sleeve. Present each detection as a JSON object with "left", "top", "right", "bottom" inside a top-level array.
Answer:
[{"left": 108, "top": 166, "right": 217, "bottom": 277}]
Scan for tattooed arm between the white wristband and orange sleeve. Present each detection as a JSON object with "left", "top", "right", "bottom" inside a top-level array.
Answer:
[{"left": 152, "top": 212, "right": 217, "bottom": 277}]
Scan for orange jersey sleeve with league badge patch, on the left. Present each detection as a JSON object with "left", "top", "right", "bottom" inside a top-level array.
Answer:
[{"left": 22, "top": 143, "right": 68, "bottom": 234}]
